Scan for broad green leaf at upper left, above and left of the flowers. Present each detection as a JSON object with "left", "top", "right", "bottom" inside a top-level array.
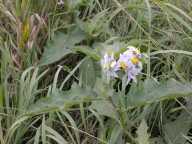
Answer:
[{"left": 40, "top": 28, "right": 85, "bottom": 65}]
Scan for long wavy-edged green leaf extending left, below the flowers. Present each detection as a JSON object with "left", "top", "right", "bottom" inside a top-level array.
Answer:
[{"left": 29, "top": 84, "right": 94, "bottom": 114}]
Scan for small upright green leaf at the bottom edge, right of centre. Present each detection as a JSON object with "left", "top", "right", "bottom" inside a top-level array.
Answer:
[{"left": 137, "top": 120, "right": 150, "bottom": 144}]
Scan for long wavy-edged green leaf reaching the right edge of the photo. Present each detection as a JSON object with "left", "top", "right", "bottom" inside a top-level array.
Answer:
[{"left": 127, "top": 79, "right": 192, "bottom": 108}]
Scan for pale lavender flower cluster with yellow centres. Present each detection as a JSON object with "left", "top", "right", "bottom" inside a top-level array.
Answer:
[{"left": 101, "top": 46, "right": 143, "bottom": 83}]
